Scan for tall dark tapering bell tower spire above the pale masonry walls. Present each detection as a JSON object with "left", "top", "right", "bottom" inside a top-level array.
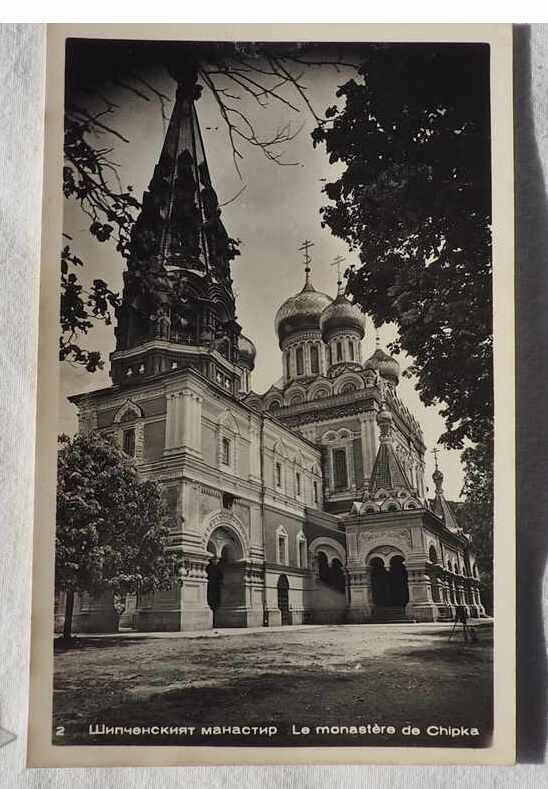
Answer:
[{"left": 111, "top": 68, "right": 242, "bottom": 394}]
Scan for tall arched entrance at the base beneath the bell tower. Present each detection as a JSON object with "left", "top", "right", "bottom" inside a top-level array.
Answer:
[{"left": 207, "top": 526, "right": 245, "bottom": 627}]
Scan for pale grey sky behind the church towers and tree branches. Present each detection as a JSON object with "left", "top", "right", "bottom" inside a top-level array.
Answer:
[{"left": 59, "top": 50, "right": 463, "bottom": 500}]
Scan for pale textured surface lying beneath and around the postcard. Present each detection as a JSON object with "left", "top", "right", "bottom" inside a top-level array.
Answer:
[{"left": 0, "top": 25, "right": 548, "bottom": 789}]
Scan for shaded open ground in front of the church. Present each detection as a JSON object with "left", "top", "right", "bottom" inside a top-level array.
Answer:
[{"left": 54, "top": 624, "right": 492, "bottom": 747}]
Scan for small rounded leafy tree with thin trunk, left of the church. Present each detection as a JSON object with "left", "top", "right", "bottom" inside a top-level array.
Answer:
[{"left": 55, "top": 433, "right": 171, "bottom": 639}]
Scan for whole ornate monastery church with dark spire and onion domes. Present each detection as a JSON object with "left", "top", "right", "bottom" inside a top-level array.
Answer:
[{"left": 63, "top": 72, "right": 485, "bottom": 632}]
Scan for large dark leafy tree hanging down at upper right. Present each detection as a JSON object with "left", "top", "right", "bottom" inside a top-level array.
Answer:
[{"left": 313, "top": 44, "right": 493, "bottom": 448}]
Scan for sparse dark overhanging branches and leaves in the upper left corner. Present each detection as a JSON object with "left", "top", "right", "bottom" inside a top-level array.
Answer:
[{"left": 63, "top": 39, "right": 353, "bottom": 372}]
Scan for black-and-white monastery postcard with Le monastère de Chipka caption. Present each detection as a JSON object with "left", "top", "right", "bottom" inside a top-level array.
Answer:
[{"left": 27, "top": 26, "right": 513, "bottom": 764}]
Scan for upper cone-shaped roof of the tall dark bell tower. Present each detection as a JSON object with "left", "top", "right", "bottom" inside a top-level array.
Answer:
[{"left": 132, "top": 81, "right": 235, "bottom": 279}]
